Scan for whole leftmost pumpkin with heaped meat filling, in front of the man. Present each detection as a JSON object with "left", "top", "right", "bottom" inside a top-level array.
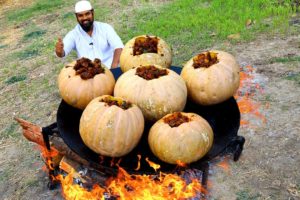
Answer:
[{"left": 58, "top": 58, "right": 115, "bottom": 110}]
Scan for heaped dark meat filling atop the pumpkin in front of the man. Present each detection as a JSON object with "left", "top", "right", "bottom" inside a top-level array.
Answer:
[{"left": 74, "top": 57, "right": 104, "bottom": 80}]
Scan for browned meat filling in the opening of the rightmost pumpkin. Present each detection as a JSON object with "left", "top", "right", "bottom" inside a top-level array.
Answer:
[{"left": 193, "top": 51, "right": 219, "bottom": 69}]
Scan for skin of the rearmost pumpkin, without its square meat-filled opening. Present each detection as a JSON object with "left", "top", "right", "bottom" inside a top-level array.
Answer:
[{"left": 120, "top": 35, "right": 172, "bottom": 72}]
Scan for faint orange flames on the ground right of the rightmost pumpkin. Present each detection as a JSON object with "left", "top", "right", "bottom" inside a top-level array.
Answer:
[{"left": 235, "top": 65, "right": 267, "bottom": 126}]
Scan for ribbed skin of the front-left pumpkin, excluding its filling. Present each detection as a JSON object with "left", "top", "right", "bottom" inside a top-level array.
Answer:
[{"left": 79, "top": 95, "right": 144, "bottom": 157}]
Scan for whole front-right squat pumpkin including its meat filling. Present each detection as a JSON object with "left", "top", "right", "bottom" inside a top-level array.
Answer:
[{"left": 148, "top": 112, "right": 214, "bottom": 164}]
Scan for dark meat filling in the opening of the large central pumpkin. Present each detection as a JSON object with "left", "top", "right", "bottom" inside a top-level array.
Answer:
[{"left": 135, "top": 65, "right": 168, "bottom": 80}]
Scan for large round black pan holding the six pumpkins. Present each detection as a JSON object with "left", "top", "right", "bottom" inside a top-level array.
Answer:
[{"left": 57, "top": 66, "right": 240, "bottom": 173}]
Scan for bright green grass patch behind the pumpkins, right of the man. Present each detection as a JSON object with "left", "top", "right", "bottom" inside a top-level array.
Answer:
[{"left": 119, "top": 0, "right": 292, "bottom": 65}]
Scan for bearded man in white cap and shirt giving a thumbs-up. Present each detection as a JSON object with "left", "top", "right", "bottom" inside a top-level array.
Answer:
[{"left": 55, "top": 0, "right": 124, "bottom": 68}]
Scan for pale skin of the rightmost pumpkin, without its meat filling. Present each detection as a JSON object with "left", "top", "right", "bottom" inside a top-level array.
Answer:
[{"left": 181, "top": 50, "right": 240, "bottom": 106}]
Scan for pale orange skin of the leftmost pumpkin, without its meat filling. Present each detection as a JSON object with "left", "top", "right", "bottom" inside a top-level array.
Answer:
[{"left": 58, "top": 61, "right": 115, "bottom": 110}]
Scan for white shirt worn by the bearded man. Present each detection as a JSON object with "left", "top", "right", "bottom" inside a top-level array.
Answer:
[{"left": 63, "top": 21, "right": 124, "bottom": 68}]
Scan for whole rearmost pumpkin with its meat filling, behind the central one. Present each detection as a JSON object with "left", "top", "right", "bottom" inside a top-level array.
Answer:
[{"left": 120, "top": 35, "right": 172, "bottom": 72}]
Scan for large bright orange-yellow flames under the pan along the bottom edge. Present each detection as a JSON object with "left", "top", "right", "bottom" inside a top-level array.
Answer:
[{"left": 57, "top": 167, "right": 205, "bottom": 200}]
